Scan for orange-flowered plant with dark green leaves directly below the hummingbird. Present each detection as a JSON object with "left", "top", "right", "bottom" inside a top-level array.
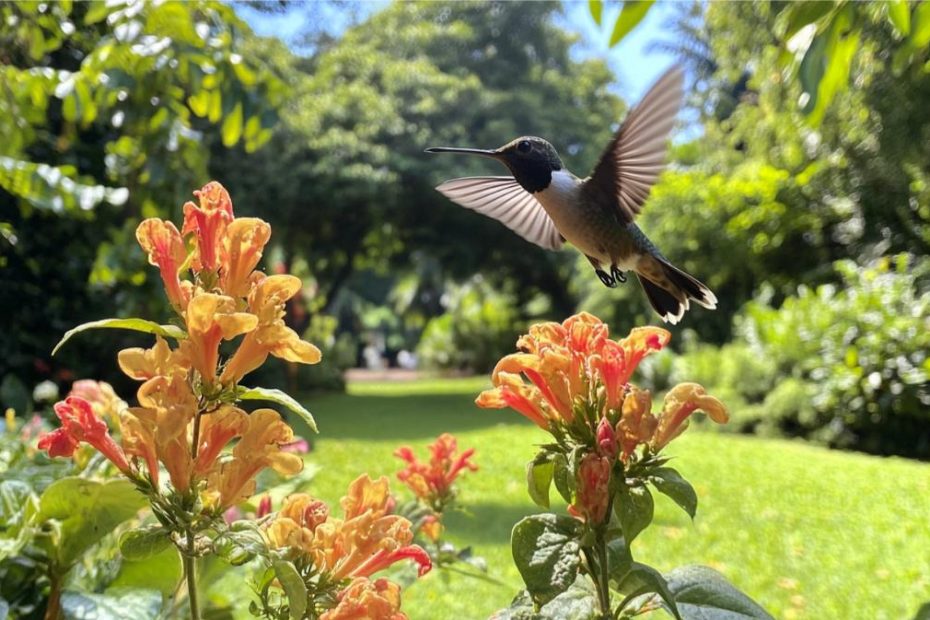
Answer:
[{"left": 477, "top": 313, "right": 768, "bottom": 618}]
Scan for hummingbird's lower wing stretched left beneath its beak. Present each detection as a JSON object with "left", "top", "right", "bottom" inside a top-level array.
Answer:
[{"left": 436, "top": 177, "right": 564, "bottom": 250}]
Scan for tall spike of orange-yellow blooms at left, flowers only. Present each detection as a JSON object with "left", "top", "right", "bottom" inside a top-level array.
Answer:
[{"left": 40, "top": 182, "right": 320, "bottom": 510}]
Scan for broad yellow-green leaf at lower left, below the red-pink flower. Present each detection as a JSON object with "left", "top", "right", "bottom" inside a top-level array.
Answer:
[{"left": 38, "top": 476, "right": 145, "bottom": 566}]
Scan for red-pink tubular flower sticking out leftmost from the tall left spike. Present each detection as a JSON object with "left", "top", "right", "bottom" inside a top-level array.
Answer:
[{"left": 38, "top": 396, "right": 133, "bottom": 477}]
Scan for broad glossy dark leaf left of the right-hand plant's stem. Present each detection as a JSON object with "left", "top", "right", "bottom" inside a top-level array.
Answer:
[{"left": 510, "top": 514, "right": 580, "bottom": 604}]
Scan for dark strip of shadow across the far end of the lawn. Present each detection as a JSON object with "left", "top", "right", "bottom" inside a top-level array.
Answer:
[{"left": 298, "top": 394, "right": 529, "bottom": 441}]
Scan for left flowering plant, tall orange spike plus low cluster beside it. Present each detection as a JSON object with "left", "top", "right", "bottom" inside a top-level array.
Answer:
[{"left": 28, "top": 182, "right": 431, "bottom": 620}]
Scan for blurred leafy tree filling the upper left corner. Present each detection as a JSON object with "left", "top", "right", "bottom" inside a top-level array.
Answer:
[{"left": 0, "top": 0, "right": 283, "bottom": 392}]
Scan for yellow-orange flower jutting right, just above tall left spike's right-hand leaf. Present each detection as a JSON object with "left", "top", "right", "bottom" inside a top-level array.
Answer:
[{"left": 220, "top": 275, "right": 321, "bottom": 385}]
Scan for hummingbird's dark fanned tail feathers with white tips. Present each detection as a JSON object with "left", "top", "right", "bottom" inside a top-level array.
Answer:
[{"left": 636, "top": 256, "right": 717, "bottom": 325}]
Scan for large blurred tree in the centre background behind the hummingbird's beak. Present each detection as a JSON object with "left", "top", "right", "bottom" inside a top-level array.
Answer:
[{"left": 212, "top": 3, "right": 623, "bottom": 354}]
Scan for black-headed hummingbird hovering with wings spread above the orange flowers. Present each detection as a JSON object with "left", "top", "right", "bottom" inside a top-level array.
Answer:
[{"left": 426, "top": 67, "right": 717, "bottom": 325}]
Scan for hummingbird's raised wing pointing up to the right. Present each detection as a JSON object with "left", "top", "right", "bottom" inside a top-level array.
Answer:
[{"left": 585, "top": 67, "right": 684, "bottom": 223}]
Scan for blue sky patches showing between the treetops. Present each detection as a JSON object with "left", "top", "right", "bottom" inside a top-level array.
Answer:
[{"left": 237, "top": 0, "right": 675, "bottom": 103}]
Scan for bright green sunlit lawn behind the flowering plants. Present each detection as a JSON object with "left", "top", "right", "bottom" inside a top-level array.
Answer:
[{"left": 294, "top": 379, "right": 930, "bottom": 620}]
